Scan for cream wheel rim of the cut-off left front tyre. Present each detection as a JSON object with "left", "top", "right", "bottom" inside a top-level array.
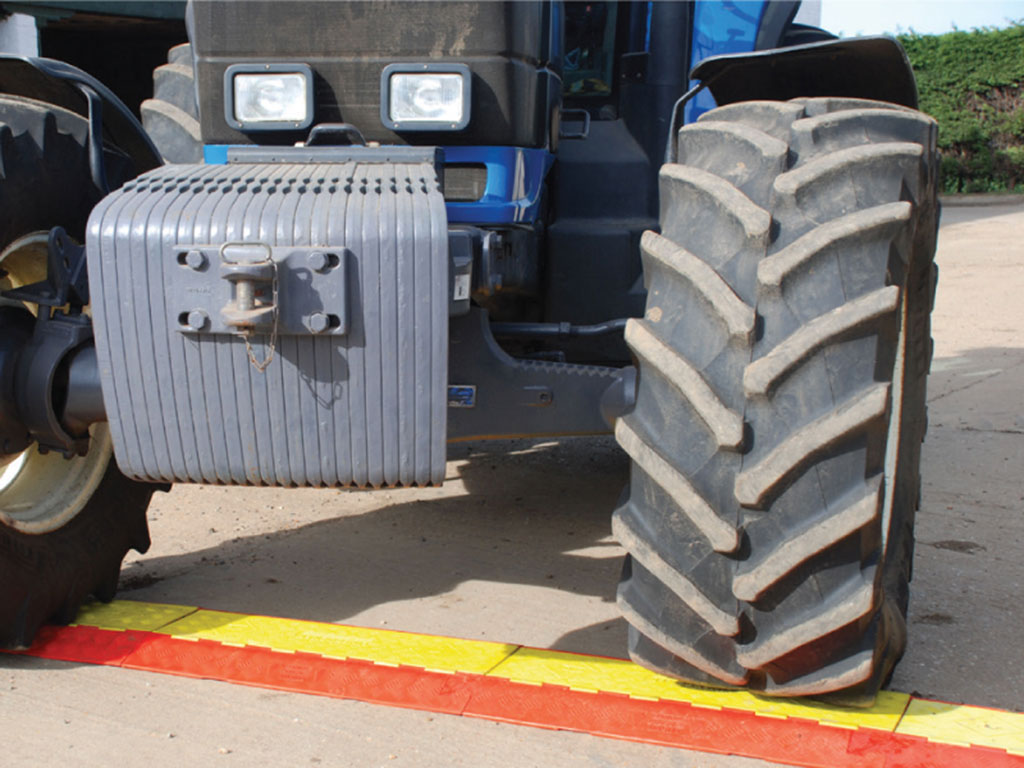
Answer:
[{"left": 0, "top": 232, "right": 112, "bottom": 535}]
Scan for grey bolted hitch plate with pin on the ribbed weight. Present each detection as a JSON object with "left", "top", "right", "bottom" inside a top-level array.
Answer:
[{"left": 167, "top": 243, "right": 354, "bottom": 336}]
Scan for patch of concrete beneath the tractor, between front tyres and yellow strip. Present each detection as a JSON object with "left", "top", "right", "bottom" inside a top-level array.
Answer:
[{"left": 119, "top": 438, "right": 628, "bottom": 655}]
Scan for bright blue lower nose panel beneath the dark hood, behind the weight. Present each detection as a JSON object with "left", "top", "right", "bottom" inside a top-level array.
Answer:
[{"left": 203, "top": 144, "right": 555, "bottom": 224}]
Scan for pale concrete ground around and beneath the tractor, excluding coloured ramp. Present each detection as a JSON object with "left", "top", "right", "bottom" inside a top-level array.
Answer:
[{"left": 0, "top": 205, "right": 1024, "bottom": 767}]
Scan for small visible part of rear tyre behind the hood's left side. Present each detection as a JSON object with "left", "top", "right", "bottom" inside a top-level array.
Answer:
[{"left": 139, "top": 43, "right": 203, "bottom": 163}]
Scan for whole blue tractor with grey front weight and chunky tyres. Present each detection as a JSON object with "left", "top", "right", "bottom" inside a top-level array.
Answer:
[{"left": 0, "top": 0, "right": 938, "bottom": 701}]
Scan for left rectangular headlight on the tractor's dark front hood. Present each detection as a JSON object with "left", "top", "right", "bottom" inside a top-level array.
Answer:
[{"left": 224, "top": 65, "right": 313, "bottom": 131}]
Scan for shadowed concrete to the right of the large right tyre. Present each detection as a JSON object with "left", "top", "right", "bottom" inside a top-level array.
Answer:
[{"left": 892, "top": 347, "right": 1024, "bottom": 711}]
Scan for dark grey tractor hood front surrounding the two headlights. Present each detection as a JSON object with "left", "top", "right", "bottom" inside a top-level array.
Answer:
[{"left": 187, "top": 0, "right": 561, "bottom": 146}]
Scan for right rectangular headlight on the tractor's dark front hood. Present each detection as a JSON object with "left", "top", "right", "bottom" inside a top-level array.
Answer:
[{"left": 381, "top": 63, "right": 470, "bottom": 131}]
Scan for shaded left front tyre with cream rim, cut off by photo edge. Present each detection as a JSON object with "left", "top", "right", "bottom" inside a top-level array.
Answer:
[{"left": 0, "top": 95, "right": 157, "bottom": 649}]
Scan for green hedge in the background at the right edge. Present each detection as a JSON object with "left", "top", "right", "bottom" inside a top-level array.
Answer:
[{"left": 899, "top": 22, "right": 1024, "bottom": 193}]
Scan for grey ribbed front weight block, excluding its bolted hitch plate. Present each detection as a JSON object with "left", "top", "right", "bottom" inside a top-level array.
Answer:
[{"left": 87, "top": 163, "right": 449, "bottom": 487}]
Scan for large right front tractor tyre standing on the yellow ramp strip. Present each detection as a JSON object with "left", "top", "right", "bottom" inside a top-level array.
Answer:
[{"left": 613, "top": 98, "right": 938, "bottom": 703}]
